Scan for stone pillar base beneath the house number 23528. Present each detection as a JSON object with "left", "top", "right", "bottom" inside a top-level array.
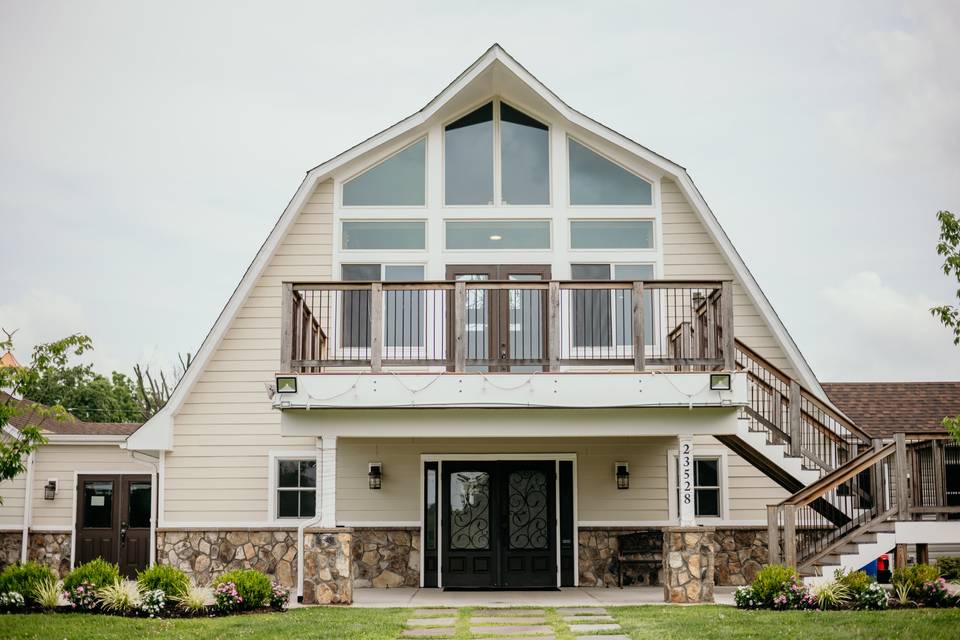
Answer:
[{"left": 663, "top": 527, "right": 715, "bottom": 604}]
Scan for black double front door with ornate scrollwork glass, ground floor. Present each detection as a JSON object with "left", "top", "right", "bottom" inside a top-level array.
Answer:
[{"left": 441, "top": 461, "right": 557, "bottom": 589}]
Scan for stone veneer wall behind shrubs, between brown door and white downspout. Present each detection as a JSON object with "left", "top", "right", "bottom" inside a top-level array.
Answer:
[{"left": 157, "top": 529, "right": 297, "bottom": 588}]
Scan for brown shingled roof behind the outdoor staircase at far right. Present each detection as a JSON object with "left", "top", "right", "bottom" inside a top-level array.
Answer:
[{"left": 823, "top": 382, "right": 960, "bottom": 438}]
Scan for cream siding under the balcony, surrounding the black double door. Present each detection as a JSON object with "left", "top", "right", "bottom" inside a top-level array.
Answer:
[{"left": 337, "top": 438, "right": 677, "bottom": 525}]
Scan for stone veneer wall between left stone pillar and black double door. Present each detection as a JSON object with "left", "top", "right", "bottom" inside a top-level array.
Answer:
[{"left": 353, "top": 528, "right": 420, "bottom": 588}]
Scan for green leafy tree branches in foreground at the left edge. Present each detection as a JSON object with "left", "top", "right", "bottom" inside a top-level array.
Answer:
[{"left": 0, "top": 331, "right": 91, "bottom": 503}]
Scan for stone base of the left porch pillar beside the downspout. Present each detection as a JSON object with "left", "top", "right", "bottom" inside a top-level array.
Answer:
[{"left": 303, "top": 528, "right": 353, "bottom": 604}]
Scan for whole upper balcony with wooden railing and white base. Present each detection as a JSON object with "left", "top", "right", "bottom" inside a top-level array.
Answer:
[{"left": 274, "top": 280, "right": 749, "bottom": 410}]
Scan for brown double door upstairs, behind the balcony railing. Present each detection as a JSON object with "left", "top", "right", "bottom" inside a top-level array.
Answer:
[{"left": 447, "top": 264, "right": 550, "bottom": 371}]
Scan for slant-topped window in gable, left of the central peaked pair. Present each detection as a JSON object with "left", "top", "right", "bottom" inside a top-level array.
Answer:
[{"left": 343, "top": 138, "right": 427, "bottom": 207}]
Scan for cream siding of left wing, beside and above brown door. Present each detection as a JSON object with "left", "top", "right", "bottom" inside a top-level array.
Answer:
[{"left": 30, "top": 444, "right": 153, "bottom": 531}]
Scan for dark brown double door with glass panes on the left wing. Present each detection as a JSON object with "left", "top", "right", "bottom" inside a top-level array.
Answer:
[{"left": 76, "top": 475, "right": 153, "bottom": 578}]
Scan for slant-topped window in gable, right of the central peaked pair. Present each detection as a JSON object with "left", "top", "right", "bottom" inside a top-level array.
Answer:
[{"left": 569, "top": 138, "right": 653, "bottom": 206}]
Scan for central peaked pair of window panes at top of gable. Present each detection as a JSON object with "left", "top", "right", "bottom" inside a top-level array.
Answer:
[{"left": 444, "top": 101, "right": 550, "bottom": 206}]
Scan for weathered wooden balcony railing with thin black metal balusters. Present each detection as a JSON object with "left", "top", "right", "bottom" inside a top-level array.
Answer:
[{"left": 281, "top": 280, "right": 735, "bottom": 373}]
